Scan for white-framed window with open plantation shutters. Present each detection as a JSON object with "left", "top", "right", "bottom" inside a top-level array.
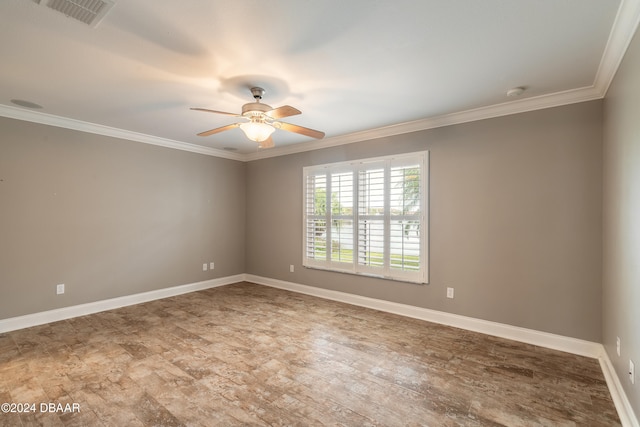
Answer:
[{"left": 303, "top": 151, "right": 429, "bottom": 283}]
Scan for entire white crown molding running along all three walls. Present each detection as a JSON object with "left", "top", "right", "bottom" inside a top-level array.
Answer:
[{"left": 0, "top": 0, "right": 640, "bottom": 162}]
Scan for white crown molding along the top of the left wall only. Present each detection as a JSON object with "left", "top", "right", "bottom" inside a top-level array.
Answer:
[{"left": 0, "top": 105, "right": 244, "bottom": 161}]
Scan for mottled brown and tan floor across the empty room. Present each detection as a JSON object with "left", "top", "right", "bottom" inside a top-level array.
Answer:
[{"left": 0, "top": 283, "right": 620, "bottom": 426}]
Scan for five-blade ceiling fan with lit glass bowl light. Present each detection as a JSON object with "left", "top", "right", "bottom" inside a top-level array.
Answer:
[{"left": 192, "top": 87, "right": 324, "bottom": 148}]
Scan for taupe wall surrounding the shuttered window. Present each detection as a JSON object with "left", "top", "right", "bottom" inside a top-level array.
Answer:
[{"left": 246, "top": 101, "right": 602, "bottom": 342}]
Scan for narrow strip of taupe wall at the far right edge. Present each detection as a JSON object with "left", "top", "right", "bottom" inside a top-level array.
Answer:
[{"left": 603, "top": 29, "right": 640, "bottom": 418}]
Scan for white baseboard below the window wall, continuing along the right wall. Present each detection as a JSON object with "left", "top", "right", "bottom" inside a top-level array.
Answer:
[{"left": 245, "top": 274, "right": 640, "bottom": 427}]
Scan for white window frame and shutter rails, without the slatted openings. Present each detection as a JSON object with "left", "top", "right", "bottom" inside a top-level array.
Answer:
[{"left": 302, "top": 151, "right": 429, "bottom": 284}]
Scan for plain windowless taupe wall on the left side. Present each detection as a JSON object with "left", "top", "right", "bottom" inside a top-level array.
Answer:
[{"left": 0, "top": 118, "right": 245, "bottom": 319}]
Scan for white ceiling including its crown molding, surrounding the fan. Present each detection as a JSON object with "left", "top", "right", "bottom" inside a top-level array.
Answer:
[{"left": 0, "top": 0, "right": 640, "bottom": 160}]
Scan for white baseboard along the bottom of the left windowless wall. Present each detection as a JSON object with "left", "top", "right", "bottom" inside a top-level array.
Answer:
[{"left": 0, "top": 274, "right": 245, "bottom": 333}]
